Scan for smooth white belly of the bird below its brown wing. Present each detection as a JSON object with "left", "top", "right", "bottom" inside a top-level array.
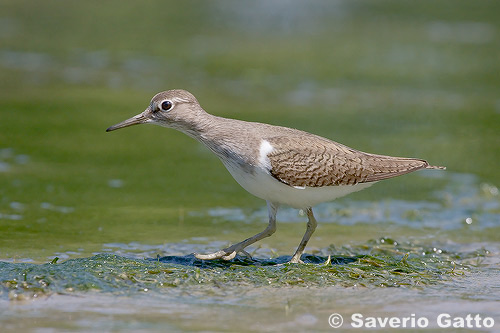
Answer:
[{"left": 222, "top": 160, "right": 374, "bottom": 208}]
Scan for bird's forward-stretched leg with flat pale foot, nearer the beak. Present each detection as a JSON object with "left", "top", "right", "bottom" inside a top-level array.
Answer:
[{"left": 194, "top": 201, "right": 278, "bottom": 260}]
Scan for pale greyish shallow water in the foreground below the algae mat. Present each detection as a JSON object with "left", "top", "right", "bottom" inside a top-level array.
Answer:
[{"left": 1, "top": 250, "right": 499, "bottom": 331}]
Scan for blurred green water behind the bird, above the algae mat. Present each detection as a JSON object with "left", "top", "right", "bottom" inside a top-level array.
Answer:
[{"left": 0, "top": 0, "right": 500, "bottom": 262}]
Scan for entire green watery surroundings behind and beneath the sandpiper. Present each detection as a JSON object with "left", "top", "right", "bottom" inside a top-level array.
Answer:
[{"left": 0, "top": 1, "right": 500, "bottom": 331}]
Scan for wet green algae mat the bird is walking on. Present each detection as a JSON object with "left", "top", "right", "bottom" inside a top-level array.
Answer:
[{"left": 0, "top": 238, "right": 488, "bottom": 300}]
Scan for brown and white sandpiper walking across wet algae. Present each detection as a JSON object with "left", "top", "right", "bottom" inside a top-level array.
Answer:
[{"left": 106, "top": 89, "right": 446, "bottom": 263}]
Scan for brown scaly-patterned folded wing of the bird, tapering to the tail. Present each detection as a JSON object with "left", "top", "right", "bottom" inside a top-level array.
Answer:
[{"left": 267, "top": 136, "right": 436, "bottom": 187}]
